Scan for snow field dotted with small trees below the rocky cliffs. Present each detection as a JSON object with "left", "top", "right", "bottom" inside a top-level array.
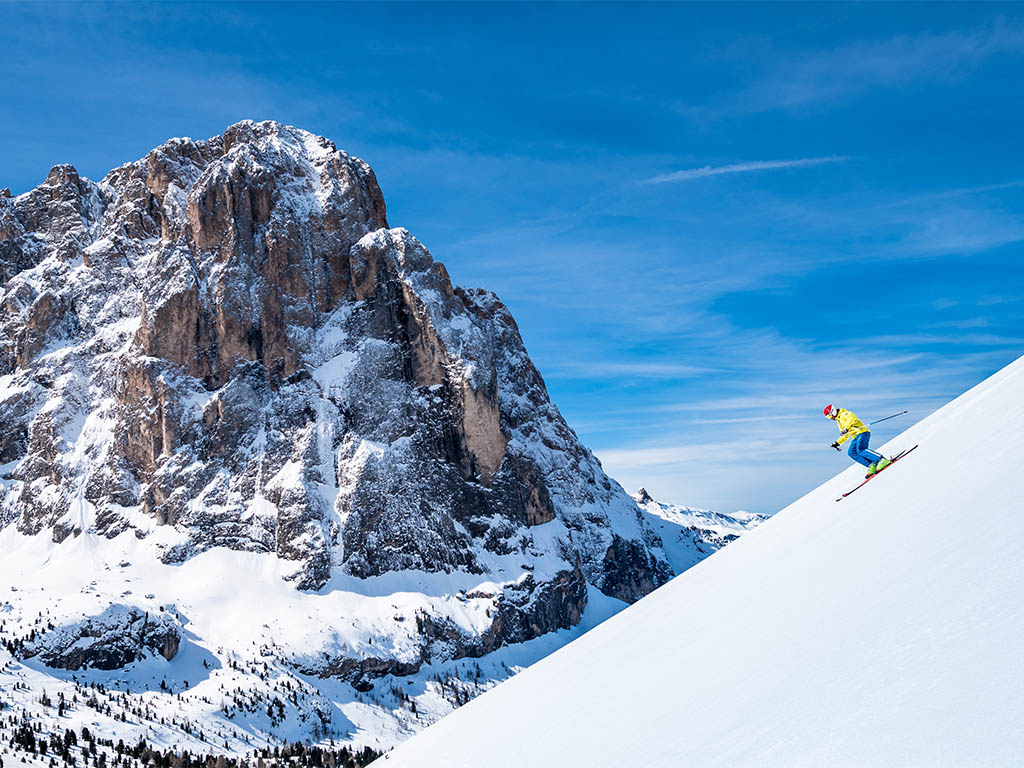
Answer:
[{"left": 0, "top": 526, "right": 625, "bottom": 756}]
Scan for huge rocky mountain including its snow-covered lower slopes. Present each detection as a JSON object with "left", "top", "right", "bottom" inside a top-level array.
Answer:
[{"left": 0, "top": 122, "right": 761, "bottom": 755}]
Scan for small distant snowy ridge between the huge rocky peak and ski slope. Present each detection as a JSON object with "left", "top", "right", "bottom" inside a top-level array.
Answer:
[{"left": 632, "top": 488, "right": 769, "bottom": 573}]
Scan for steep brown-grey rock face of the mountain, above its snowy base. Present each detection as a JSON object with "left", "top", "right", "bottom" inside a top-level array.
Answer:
[{"left": 0, "top": 122, "right": 671, "bottom": 654}]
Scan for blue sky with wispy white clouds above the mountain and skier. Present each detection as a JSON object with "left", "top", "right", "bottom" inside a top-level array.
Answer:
[{"left": 0, "top": 3, "right": 1024, "bottom": 512}]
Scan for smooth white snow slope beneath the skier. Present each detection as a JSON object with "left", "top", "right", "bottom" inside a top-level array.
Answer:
[{"left": 374, "top": 358, "right": 1024, "bottom": 768}]
